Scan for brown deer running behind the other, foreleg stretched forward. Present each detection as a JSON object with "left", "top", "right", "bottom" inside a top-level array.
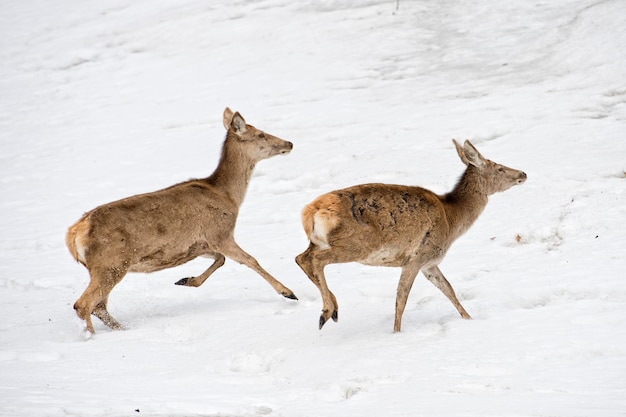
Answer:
[{"left": 66, "top": 107, "right": 297, "bottom": 334}]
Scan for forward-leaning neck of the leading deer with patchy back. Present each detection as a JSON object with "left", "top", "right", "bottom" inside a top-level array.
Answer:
[{"left": 443, "top": 165, "right": 489, "bottom": 239}]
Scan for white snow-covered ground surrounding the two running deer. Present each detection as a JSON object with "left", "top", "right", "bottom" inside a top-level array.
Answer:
[{"left": 0, "top": 0, "right": 626, "bottom": 417}]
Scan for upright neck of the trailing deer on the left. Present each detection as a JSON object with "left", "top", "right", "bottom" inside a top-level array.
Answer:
[{"left": 208, "top": 131, "right": 256, "bottom": 206}]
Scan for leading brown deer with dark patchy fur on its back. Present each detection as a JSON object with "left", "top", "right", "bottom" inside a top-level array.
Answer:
[{"left": 296, "top": 139, "right": 527, "bottom": 333}]
